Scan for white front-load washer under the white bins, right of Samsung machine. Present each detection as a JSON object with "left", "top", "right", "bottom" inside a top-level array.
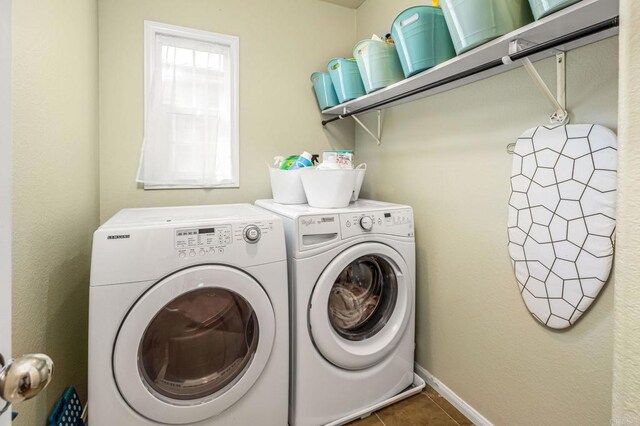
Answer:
[{"left": 256, "top": 200, "right": 415, "bottom": 426}]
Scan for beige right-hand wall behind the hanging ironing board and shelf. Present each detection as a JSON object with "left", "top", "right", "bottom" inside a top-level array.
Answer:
[{"left": 356, "top": 0, "right": 618, "bottom": 426}]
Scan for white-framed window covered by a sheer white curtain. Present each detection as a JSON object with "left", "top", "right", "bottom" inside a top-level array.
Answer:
[{"left": 137, "top": 21, "right": 239, "bottom": 189}]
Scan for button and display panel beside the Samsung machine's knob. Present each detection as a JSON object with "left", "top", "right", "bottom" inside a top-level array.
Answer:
[{"left": 175, "top": 225, "right": 233, "bottom": 258}]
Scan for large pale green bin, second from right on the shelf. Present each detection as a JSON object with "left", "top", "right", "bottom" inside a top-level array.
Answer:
[{"left": 442, "top": 0, "right": 533, "bottom": 54}]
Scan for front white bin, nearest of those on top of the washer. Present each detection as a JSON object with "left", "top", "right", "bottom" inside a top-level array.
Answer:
[{"left": 300, "top": 169, "right": 360, "bottom": 209}]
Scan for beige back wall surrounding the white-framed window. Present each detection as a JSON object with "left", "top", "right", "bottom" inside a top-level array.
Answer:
[{"left": 99, "top": 0, "right": 355, "bottom": 221}]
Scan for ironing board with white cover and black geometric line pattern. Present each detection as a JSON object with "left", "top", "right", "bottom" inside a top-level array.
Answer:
[{"left": 508, "top": 124, "right": 617, "bottom": 329}]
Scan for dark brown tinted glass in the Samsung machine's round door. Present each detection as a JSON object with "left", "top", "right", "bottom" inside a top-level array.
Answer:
[{"left": 138, "top": 288, "right": 258, "bottom": 400}]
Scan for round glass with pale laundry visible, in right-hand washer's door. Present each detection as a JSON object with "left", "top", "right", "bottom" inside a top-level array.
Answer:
[{"left": 328, "top": 255, "right": 398, "bottom": 340}]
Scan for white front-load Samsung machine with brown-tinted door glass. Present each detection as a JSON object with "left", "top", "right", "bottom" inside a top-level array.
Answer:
[{"left": 89, "top": 204, "right": 289, "bottom": 426}]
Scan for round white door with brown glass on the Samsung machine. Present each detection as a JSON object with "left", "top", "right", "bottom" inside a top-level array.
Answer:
[{"left": 110, "top": 265, "right": 275, "bottom": 424}]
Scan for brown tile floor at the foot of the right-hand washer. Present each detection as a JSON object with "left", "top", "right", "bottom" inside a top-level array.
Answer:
[{"left": 349, "top": 385, "right": 473, "bottom": 426}]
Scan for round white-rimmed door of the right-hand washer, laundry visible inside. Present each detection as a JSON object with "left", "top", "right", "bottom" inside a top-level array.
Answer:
[{"left": 309, "top": 243, "right": 414, "bottom": 370}]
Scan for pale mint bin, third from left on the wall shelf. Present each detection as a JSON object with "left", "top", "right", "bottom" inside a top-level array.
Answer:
[{"left": 353, "top": 40, "right": 404, "bottom": 93}]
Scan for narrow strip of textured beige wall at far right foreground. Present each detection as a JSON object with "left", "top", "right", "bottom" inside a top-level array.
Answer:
[{"left": 612, "top": 0, "right": 640, "bottom": 426}]
